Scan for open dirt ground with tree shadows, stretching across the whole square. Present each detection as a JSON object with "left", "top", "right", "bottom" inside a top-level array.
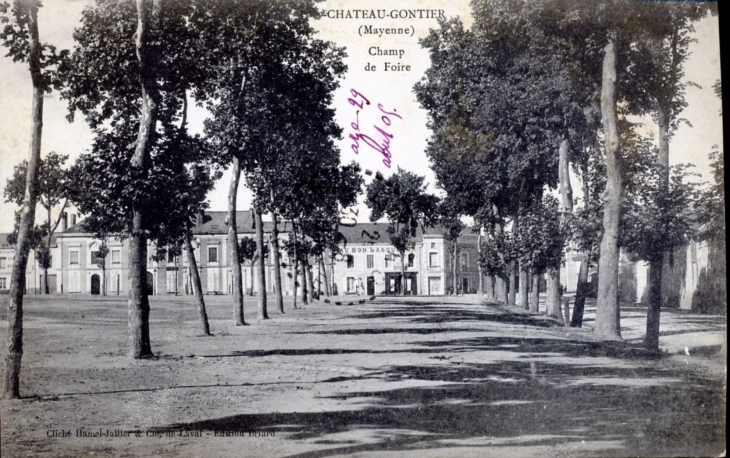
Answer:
[{"left": 0, "top": 296, "right": 727, "bottom": 458}]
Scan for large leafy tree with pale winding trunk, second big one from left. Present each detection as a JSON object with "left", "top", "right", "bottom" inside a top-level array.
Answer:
[{"left": 60, "top": 0, "right": 210, "bottom": 358}]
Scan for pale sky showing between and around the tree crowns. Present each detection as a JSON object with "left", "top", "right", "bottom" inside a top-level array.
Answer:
[{"left": 0, "top": 0, "right": 722, "bottom": 232}]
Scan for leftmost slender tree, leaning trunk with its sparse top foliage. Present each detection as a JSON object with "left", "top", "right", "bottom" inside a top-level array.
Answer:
[{"left": 0, "top": 0, "right": 63, "bottom": 398}]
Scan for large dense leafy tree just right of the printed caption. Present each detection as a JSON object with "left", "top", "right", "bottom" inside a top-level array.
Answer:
[{"left": 415, "top": 5, "right": 592, "bottom": 305}]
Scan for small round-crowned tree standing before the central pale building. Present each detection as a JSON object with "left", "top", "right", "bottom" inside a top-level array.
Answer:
[{"left": 366, "top": 167, "right": 438, "bottom": 294}]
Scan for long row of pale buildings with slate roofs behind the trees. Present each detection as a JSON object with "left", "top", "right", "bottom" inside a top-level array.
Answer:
[{"left": 0, "top": 211, "right": 479, "bottom": 295}]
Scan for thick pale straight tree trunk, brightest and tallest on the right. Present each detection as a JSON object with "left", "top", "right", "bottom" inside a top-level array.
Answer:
[{"left": 595, "top": 36, "right": 623, "bottom": 340}]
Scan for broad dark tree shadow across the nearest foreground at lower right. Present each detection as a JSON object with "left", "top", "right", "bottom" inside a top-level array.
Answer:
[{"left": 154, "top": 362, "right": 725, "bottom": 457}]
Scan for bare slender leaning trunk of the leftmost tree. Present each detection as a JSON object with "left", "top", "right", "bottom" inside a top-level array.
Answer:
[{"left": 3, "top": 3, "right": 48, "bottom": 399}]
